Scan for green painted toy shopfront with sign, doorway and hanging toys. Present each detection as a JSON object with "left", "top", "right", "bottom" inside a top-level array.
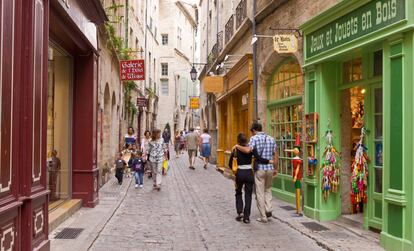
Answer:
[{"left": 268, "top": 0, "right": 414, "bottom": 250}]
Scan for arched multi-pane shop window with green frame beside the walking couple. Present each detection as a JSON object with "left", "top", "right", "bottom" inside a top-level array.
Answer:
[{"left": 267, "top": 59, "right": 303, "bottom": 175}]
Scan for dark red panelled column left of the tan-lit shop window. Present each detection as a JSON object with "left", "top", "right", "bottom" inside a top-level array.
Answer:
[{"left": 19, "top": 0, "right": 49, "bottom": 250}]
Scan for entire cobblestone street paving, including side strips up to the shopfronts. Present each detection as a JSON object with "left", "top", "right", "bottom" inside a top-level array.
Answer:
[{"left": 49, "top": 152, "right": 383, "bottom": 251}]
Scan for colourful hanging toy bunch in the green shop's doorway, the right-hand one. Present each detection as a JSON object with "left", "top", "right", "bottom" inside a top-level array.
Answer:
[{"left": 351, "top": 127, "right": 370, "bottom": 212}]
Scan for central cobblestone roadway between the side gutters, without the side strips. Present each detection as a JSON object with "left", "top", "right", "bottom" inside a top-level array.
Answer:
[{"left": 90, "top": 155, "right": 321, "bottom": 250}]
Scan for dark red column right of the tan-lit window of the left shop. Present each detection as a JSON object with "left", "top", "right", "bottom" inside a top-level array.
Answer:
[{"left": 72, "top": 53, "right": 99, "bottom": 207}]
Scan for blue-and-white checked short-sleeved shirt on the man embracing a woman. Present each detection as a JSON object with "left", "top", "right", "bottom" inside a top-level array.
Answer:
[{"left": 249, "top": 132, "right": 277, "bottom": 170}]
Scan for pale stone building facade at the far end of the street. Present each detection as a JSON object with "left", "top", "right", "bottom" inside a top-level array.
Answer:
[{"left": 157, "top": 0, "right": 198, "bottom": 133}]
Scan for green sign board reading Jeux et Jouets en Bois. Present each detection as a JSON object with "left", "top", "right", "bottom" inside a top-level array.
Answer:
[{"left": 306, "top": 0, "right": 405, "bottom": 58}]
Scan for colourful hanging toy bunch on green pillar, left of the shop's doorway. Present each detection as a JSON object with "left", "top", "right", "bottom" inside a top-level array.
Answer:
[{"left": 322, "top": 125, "right": 340, "bottom": 201}]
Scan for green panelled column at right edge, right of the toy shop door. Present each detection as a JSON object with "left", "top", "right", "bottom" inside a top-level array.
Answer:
[{"left": 381, "top": 32, "right": 414, "bottom": 250}]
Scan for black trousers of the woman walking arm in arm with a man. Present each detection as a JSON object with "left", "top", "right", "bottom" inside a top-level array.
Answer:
[{"left": 236, "top": 169, "right": 254, "bottom": 218}]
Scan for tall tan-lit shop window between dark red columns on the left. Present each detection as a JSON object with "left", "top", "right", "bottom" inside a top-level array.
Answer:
[{"left": 46, "top": 43, "right": 72, "bottom": 206}]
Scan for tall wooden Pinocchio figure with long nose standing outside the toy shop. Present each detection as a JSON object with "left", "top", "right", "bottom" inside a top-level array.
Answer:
[{"left": 285, "top": 133, "right": 303, "bottom": 216}]
